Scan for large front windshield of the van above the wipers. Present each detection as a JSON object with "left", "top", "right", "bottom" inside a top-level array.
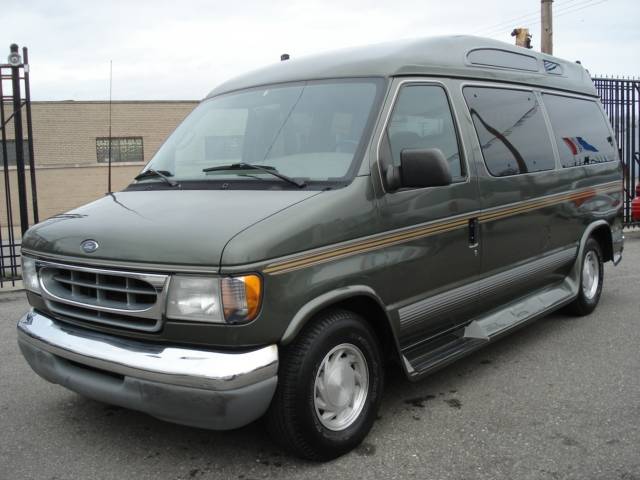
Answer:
[{"left": 139, "top": 79, "right": 381, "bottom": 187}]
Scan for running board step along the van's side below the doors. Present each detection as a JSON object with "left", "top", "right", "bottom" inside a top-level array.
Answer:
[{"left": 402, "top": 279, "right": 575, "bottom": 380}]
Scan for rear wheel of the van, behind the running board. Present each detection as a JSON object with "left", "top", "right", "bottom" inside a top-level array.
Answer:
[{"left": 567, "top": 238, "right": 604, "bottom": 316}]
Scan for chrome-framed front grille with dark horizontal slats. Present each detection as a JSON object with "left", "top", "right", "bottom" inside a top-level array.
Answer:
[{"left": 38, "top": 262, "right": 168, "bottom": 331}]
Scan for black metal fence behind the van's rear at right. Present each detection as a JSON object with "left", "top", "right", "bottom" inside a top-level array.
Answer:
[{"left": 593, "top": 77, "right": 640, "bottom": 226}]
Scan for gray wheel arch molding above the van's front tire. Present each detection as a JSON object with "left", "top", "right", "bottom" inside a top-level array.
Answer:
[{"left": 280, "top": 285, "right": 394, "bottom": 345}]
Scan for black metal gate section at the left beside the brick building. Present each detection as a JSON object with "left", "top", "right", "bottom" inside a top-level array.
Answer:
[{"left": 0, "top": 44, "right": 38, "bottom": 288}]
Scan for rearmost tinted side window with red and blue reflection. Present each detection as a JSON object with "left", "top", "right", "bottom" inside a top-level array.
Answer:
[{"left": 542, "top": 94, "right": 616, "bottom": 167}]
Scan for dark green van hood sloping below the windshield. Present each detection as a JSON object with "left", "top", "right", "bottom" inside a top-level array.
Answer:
[{"left": 22, "top": 190, "right": 321, "bottom": 266}]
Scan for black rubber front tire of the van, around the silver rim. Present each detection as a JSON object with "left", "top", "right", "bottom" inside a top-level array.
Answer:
[{"left": 266, "top": 310, "right": 384, "bottom": 461}]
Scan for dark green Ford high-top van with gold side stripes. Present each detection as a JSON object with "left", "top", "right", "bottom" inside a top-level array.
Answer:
[{"left": 18, "top": 36, "right": 623, "bottom": 460}]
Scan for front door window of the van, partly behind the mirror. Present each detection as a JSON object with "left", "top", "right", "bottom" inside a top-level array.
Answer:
[{"left": 387, "top": 85, "right": 464, "bottom": 180}]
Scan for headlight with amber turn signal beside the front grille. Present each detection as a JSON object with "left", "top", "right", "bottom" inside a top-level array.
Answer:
[{"left": 167, "top": 275, "right": 262, "bottom": 323}]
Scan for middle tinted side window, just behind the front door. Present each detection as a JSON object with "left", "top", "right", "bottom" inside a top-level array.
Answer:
[{"left": 463, "top": 87, "right": 555, "bottom": 177}]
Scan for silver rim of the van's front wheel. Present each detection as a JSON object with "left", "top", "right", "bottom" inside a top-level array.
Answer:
[{"left": 313, "top": 343, "right": 369, "bottom": 431}]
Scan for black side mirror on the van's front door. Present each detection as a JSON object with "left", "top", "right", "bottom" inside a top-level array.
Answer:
[{"left": 386, "top": 148, "right": 452, "bottom": 190}]
